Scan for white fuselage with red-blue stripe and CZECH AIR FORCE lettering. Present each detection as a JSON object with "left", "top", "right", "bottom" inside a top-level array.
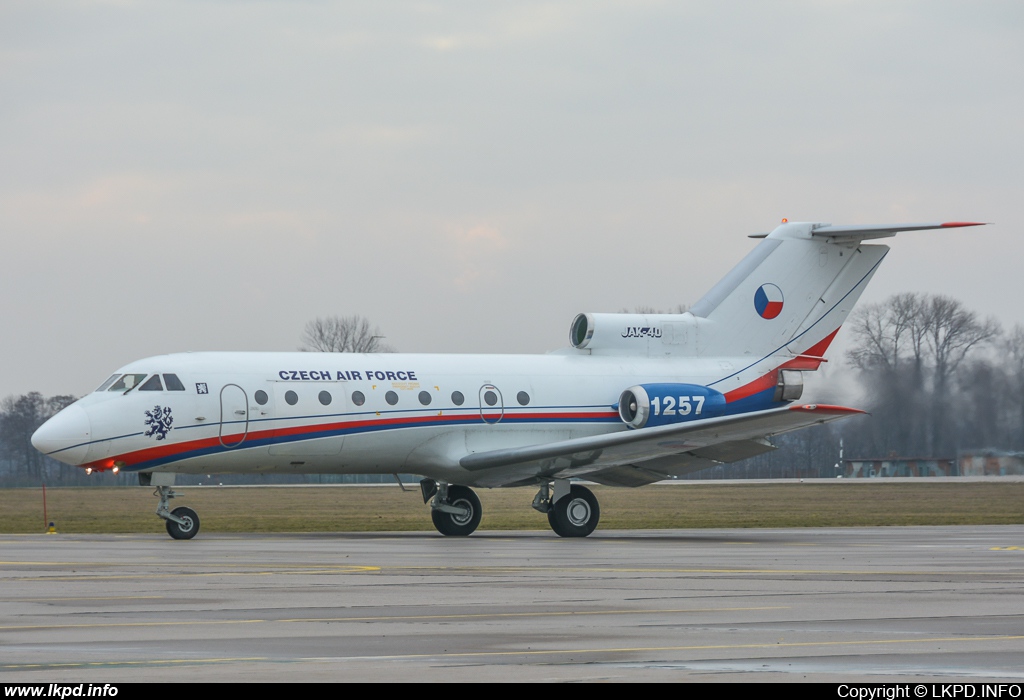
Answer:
[{"left": 40, "top": 350, "right": 778, "bottom": 486}]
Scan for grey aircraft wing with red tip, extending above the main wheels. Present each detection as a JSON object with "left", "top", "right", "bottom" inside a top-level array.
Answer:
[{"left": 460, "top": 404, "right": 864, "bottom": 486}]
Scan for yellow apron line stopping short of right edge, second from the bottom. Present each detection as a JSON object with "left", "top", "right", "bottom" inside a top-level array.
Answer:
[{"left": 0, "top": 605, "right": 790, "bottom": 631}]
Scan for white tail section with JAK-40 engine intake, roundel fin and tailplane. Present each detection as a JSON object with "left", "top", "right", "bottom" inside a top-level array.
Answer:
[{"left": 569, "top": 222, "right": 981, "bottom": 360}]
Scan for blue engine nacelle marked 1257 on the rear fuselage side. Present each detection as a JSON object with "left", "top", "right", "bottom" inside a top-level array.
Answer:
[{"left": 618, "top": 384, "right": 725, "bottom": 428}]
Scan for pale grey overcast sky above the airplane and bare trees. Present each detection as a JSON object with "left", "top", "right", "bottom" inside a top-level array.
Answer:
[{"left": 0, "top": 0, "right": 1024, "bottom": 397}]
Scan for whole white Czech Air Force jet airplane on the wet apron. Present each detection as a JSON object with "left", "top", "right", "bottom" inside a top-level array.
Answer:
[{"left": 32, "top": 219, "right": 982, "bottom": 539}]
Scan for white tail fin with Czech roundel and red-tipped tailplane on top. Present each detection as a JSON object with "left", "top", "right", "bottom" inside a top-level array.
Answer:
[{"left": 690, "top": 222, "right": 979, "bottom": 360}]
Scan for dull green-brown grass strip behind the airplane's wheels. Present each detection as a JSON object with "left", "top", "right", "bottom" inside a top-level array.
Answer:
[{"left": 0, "top": 480, "right": 1024, "bottom": 534}]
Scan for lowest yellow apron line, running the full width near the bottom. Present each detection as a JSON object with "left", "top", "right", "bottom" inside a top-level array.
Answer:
[{"left": 0, "top": 635, "right": 1024, "bottom": 670}]
